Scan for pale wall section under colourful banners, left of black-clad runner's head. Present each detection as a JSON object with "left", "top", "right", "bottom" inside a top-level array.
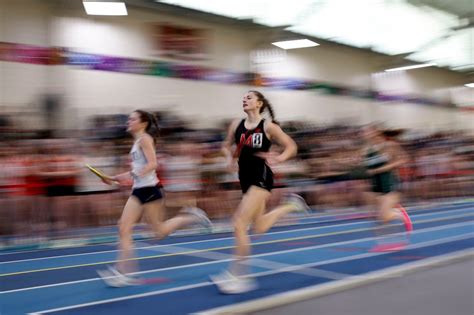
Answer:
[{"left": 68, "top": 70, "right": 254, "bottom": 126}]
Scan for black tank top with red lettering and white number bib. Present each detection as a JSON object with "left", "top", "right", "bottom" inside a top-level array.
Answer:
[{"left": 235, "top": 119, "right": 272, "bottom": 170}]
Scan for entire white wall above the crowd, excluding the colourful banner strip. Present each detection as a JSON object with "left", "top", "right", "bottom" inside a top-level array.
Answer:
[{"left": 0, "top": 0, "right": 474, "bottom": 129}]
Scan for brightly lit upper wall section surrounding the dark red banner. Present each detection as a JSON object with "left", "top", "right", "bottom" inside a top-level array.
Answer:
[{"left": 51, "top": 7, "right": 251, "bottom": 71}]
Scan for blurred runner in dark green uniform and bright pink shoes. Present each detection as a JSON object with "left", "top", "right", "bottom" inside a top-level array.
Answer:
[{"left": 363, "top": 126, "right": 412, "bottom": 251}]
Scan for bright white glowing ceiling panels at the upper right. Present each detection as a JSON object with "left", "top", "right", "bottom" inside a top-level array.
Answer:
[{"left": 145, "top": 0, "right": 474, "bottom": 72}]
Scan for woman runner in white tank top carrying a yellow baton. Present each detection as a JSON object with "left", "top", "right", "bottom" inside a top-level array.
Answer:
[{"left": 98, "top": 110, "right": 211, "bottom": 287}]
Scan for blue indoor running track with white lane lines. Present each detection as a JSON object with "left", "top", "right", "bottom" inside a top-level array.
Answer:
[{"left": 0, "top": 202, "right": 474, "bottom": 315}]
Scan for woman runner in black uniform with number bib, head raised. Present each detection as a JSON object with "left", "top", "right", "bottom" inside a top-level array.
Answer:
[{"left": 211, "top": 91, "right": 308, "bottom": 294}]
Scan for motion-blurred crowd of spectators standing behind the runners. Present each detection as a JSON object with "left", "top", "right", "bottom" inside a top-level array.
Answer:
[{"left": 0, "top": 113, "right": 474, "bottom": 238}]
